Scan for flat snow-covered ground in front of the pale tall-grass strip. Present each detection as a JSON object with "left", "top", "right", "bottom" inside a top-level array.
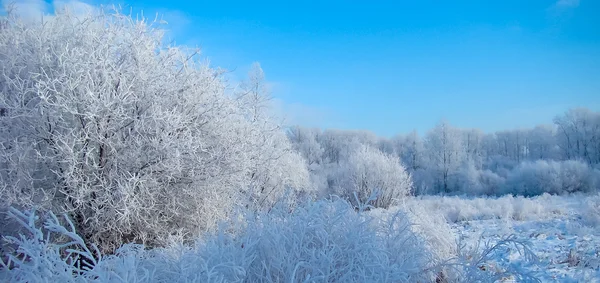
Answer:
[{"left": 452, "top": 218, "right": 600, "bottom": 282}]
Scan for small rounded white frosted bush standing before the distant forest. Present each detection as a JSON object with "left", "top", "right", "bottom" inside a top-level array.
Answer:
[{"left": 337, "top": 145, "right": 412, "bottom": 208}]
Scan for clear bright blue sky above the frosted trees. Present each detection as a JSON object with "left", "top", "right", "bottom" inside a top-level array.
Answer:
[{"left": 5, "top": 0, "right": 600, "bottom": 136}]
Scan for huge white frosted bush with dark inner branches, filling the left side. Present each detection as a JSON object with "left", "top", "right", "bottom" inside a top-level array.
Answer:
[{"left": 0, "top": 8, "right": 308, "bottom": 251}]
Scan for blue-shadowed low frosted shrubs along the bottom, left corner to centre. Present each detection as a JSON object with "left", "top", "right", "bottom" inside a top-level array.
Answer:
[{"left": 0, "top": 200, "right": 435, "bottom": 282}]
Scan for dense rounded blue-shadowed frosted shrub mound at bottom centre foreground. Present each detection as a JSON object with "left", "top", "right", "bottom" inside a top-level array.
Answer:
[{"left": 195, "top": 201, "right": 434, "bottom": 282}]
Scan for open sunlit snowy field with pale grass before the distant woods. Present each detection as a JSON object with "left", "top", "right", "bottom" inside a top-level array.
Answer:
[{"left": 376, "top": 195, "right": 600, "bottom": 282}]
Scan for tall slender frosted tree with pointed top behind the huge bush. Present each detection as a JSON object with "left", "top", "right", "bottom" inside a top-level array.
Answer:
[{"left": 236, "top": 63, "right": 310, "bottom": 211}]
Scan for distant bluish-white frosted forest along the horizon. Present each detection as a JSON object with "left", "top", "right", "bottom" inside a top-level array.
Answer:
[{"left": 288, "top": 108, "right": 600, "bottom": 198}]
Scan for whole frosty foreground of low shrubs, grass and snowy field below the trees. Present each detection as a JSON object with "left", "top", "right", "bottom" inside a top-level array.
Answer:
[{"left": 0, "top": 192, "right": 600, "bottom": 282}]
